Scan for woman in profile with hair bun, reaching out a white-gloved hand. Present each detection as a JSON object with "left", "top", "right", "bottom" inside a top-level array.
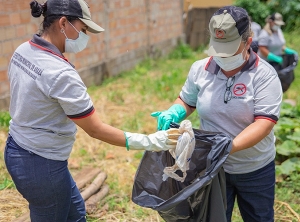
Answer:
[{"left": 4, "top": 0, "right": 178, "bottom": 222}]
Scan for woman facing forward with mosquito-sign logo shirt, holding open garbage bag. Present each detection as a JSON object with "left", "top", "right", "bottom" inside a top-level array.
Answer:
[{"left": 151, "top": 6, "right": 282, "bottom": 222}]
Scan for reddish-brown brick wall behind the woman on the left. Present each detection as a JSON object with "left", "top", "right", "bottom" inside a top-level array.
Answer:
[{"left": 0, "top": 0, "right": 183, "bottom": 110}]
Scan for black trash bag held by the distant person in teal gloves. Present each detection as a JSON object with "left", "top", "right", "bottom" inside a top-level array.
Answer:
[{"left": 269, "top": 54, "right": 298, "bottom": 92}]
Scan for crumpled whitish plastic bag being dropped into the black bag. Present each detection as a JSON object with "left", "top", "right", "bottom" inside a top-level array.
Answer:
[{"left": 163, "top": 120, "right": 195, "bottom": 182}]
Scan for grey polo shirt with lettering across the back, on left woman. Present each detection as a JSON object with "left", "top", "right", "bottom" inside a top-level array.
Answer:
[{"left": 8, "top": 35, "right": 94, "bottom": 160}]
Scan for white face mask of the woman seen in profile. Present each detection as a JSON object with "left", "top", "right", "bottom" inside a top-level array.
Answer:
[{"left": 62, "top": 22, "right": 90, "bottom": 53}]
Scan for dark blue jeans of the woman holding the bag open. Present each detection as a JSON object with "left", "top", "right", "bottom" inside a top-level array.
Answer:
[{"left": 226, "top": 161, "right": 275, "bottom": 222}]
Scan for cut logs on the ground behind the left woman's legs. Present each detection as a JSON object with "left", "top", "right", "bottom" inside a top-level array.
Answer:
[{"left": 15, "top": 167, "right": 109, "bottom": 222}]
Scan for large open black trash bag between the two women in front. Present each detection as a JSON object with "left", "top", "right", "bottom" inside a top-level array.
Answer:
[{"left": 132, "top": 123, "right": 232, "bottom": 222}]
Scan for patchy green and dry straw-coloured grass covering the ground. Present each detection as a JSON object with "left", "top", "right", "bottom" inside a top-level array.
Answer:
[{"left": 0, "top": 36, "right": 300, "bottom": 222}]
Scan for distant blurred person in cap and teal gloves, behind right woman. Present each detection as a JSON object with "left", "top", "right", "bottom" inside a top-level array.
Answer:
[{"left": 258, "top": 12, "right": 297, "bottom": 64}]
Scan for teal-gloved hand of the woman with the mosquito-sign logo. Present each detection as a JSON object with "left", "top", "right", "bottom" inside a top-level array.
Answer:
[{"left": 151, "top": 104, "right": 186, "bottom": 130}]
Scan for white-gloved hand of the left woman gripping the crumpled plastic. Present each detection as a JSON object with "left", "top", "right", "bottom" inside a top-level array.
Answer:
[{"left": 124, "top": 128, "right": 181, "bottom": 151}]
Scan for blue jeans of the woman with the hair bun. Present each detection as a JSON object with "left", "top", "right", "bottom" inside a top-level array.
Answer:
[{"left": 4, "top": 136, "right": 86, "bottom": 222}]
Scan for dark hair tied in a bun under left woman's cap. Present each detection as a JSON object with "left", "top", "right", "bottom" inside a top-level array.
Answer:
[{"left": 30, "top": 0, "right": 78, "bottom": 34}]
